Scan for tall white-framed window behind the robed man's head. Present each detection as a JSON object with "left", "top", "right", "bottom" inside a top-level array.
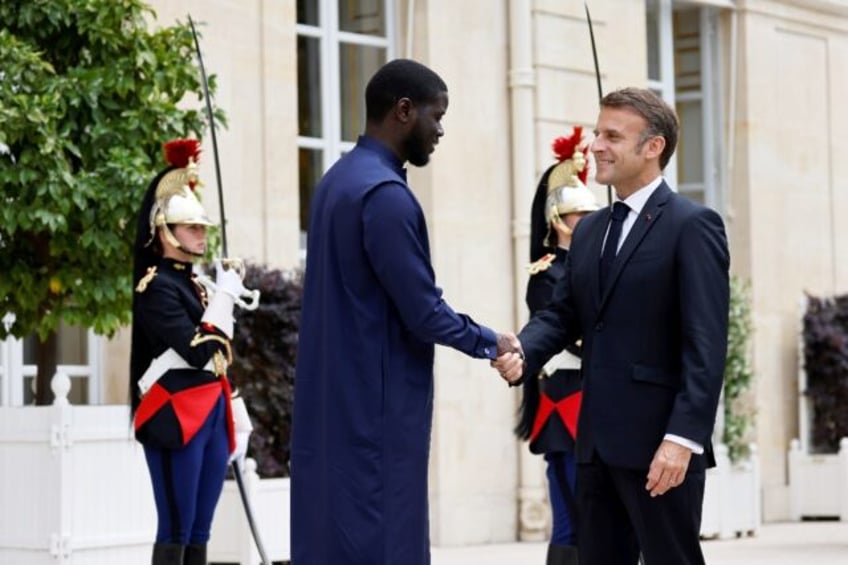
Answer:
[{"left": 297, "top": 0, "right": 394, "bottom": 240}]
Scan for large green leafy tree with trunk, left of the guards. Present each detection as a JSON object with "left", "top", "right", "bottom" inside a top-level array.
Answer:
[{"left": 0, "top": 0, "right": 220, "bottom": 404}]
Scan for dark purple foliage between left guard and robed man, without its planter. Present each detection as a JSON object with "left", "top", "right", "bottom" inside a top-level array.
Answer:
[{"left": 229, "top": 265, "right": 303, "bottom": 477}]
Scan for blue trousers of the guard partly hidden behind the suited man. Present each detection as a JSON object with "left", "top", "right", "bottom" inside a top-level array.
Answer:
[{"left": 545, "top": 452, "right": 577, "bottom": 545}]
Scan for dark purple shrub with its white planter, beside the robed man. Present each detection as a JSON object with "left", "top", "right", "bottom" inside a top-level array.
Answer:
[{"left": 209, "top": 265, "right": 303, "bottom": 565}]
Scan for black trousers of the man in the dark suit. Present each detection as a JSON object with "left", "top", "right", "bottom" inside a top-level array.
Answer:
[{"left": 577, "top": 457, "right": 704, "bottom": 565}]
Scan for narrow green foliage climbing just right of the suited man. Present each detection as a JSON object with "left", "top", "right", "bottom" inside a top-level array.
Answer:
[{"left": 722, "top": 277, "right": 754, "bottom": 462}]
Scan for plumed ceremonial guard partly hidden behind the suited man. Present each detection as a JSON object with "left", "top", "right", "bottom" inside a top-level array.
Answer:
[{"left": 516, "top": 127, "right": 598, "bottom": 565}]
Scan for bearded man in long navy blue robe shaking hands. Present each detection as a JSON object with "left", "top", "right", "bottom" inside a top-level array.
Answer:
[{"left": 291, "top": 60, "right": 517, "bottom": 565}]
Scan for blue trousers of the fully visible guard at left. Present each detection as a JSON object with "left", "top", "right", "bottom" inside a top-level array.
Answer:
[{"left": 144, "top": 396, "right": 229, "bottom": 545}]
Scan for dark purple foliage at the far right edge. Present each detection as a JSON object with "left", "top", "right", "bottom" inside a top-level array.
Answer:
[{"left": 803, "top": 295, "right": 848, "bottom": 453}]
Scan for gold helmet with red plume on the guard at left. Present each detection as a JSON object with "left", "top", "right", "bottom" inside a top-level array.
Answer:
[{"left": 150, "top": 139, "right": 214, "bottom": 254}]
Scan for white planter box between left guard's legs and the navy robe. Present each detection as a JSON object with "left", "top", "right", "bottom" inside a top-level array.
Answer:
[{"left": 208, "top": 459, "right": 291, "bottom": 565}]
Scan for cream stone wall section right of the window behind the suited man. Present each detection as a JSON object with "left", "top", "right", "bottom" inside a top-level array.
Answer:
[{"left": 729, "top": 2, "right": 848, "bottom": 519}]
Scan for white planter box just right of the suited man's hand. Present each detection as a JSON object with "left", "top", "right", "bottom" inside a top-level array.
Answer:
[{"left": 701, "top": 444, "right": 762, "bottom": 539}]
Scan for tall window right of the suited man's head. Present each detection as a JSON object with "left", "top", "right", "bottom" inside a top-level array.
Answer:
[{"left": 647, "top": 0, "right": 724, "bottom": 211}]
